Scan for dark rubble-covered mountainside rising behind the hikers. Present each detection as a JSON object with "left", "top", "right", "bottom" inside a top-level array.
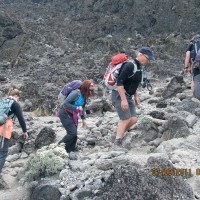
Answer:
[{"left": 0, "top": 0, "right": 200, "bottom": 115}]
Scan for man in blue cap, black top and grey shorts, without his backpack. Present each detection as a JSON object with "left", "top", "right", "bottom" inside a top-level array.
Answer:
[{"left": 111, "top": 47, "right": 155, "bottom": 146}]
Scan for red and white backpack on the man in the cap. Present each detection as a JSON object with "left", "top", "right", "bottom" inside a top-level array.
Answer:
[{"left": 103, "top": 53, "right": 142, "bottom": 90}]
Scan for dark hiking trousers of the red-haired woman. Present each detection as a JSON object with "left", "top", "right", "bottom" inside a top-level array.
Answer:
[{"left": 59, "top": 108, "right": 77, "bottom": 153}]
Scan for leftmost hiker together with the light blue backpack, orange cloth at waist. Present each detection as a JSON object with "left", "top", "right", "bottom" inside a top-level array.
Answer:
[{"left": 0, "top": 88, "right": 28, "bottom": 189}]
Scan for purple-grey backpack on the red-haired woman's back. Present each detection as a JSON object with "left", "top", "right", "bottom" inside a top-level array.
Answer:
[{"left": 58, "top": 80, "right": 82, "bottom": 104}]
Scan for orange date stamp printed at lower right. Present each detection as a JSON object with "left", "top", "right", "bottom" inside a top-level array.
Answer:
[{"left": 151, "top": 167, "right": 200, "bottom": 176}]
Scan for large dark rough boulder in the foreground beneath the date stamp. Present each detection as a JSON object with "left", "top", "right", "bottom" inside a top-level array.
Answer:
[{"left": 94, "top": 158, "right": 193, "bottom": 200}]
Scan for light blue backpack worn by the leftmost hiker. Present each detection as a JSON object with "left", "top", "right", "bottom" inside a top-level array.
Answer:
[{"left": 0, "top": 98, "right": 14, "bottom": 126}]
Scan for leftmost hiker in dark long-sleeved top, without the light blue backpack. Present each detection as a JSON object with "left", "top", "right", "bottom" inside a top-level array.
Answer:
[{"left": 0, "top": 89, "right": 28, "bottom": 189}]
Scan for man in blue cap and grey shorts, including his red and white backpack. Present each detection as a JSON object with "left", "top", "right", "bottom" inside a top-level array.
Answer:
[{"left": 104, "top": 47, "right": 155, "bottom": 147}]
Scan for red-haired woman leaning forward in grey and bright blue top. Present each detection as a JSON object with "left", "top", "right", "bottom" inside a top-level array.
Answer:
[{"left": 59, "top": 80, "right": 94, "bottom": 153}]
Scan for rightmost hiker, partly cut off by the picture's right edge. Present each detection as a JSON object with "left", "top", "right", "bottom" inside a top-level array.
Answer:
[{"left": 184, "top": 34, "right": 200, "bottom": 100}]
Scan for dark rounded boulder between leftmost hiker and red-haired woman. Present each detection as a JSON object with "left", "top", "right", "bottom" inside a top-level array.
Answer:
[{"left": 35, "top": 127, "right": 56, "bottom": 149}]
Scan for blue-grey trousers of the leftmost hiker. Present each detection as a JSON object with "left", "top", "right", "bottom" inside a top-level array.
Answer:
[{"left": 0, "top": 137, "right": 9, "bottom": 173}]
